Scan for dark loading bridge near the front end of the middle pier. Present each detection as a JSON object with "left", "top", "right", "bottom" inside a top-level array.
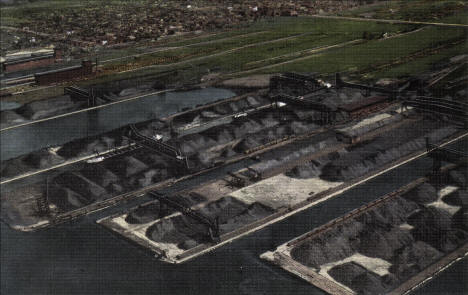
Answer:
[{"left": 149, "top": 192, "right": 220, "bottom": 243}]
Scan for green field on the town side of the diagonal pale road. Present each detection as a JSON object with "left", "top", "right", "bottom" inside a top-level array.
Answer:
[{"left": 93, "top": 17, "right": 416, "bottom": 80}]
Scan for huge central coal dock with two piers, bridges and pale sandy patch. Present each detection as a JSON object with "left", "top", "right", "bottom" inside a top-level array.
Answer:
[{"left": 1, "top": 73, "right": 466, "bottom": 263}]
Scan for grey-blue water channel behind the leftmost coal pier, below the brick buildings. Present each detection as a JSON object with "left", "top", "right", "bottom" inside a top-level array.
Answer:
[{"left": 0, "top": 88, "right": 235, "bottom": 161}]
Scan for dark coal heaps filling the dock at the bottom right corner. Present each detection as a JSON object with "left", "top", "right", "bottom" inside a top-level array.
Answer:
[{"left": 291, "top": 166, "right": 468, "bottom": 294}]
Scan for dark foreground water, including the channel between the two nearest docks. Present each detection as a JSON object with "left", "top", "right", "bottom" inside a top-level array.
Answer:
[{"left": 0, "top": 140, "right": 468, "bottom": 295}]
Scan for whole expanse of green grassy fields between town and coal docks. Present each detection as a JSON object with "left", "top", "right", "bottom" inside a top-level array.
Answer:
[{"left": 2, "top": 0, "right": 467, "bottom": 103}]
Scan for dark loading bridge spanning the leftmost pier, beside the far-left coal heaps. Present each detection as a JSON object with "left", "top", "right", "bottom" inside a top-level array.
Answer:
[{"left": 130, "top": 124, "right": 189, "bottom": 168}]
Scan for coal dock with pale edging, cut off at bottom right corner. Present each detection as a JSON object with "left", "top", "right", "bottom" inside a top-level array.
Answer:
[{"left": 262, "top": 156, "right": 468, "bottom": 294}]
